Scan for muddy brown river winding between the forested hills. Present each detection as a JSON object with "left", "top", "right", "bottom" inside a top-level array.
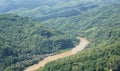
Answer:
[{"left": 24, "top": 37, "right": 89, "bottom": 71}]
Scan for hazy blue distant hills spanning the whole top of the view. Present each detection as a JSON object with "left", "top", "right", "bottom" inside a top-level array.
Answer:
[{"left": 0, "top": 0, "right": 120, "bottom": 22}]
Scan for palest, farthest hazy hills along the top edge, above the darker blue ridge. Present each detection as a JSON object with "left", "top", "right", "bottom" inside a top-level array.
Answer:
[{"left": 0, "top": 0, "right": 95, "bottom": 12}]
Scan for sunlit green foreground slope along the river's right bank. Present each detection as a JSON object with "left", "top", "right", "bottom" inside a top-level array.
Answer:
[{"left": 38, "top": 41, "right": 120, "bottom": 71}]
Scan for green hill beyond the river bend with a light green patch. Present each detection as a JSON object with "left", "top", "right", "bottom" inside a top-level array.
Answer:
[{"left": 42, "top": 2, "right": 120, "bottom": 44}]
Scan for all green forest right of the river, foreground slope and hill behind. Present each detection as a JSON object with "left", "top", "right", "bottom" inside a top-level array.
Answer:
[{"left": 38, "top": 1, "right": 120, "bottom": 71}]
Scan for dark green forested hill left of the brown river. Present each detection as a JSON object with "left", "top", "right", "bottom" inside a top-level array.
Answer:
[{"left": 0, "top": 14, "right": 75, "bottom": 71}]
